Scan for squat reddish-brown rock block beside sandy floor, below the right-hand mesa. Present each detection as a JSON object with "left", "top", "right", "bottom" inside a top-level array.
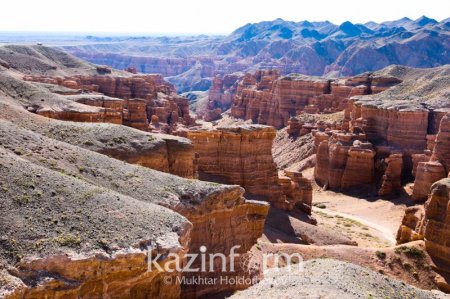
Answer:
[{"left": 314, "top": 131, "right": 375, "bottom": 190}]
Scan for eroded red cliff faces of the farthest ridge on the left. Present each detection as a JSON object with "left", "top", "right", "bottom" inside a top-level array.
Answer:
[{"left": 24, "top": 75, "right": 193, "bottom": 132}]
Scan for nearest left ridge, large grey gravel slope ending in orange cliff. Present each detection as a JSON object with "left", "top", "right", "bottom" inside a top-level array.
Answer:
[{"left": 0, "top": 120, "right": 268, "bottom": 298}]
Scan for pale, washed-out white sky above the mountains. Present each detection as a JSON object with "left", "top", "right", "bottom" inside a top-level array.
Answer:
[{"left": 0, "top": 0, "right": 450, "bottom": 34}]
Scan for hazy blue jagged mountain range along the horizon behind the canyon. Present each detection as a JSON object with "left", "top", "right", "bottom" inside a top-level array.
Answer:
[{"left": 57, "top": 16, "right": 450, "bottom": 91}]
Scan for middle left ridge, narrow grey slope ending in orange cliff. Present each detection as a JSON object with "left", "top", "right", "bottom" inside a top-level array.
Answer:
[{"left": 0, "top": 99, "right": 197, "bottom": 178}]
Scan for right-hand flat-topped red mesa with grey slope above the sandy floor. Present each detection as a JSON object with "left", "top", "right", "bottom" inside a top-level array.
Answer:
[{"left": 314, "top": 66, "right": 450, "bottom": 193}]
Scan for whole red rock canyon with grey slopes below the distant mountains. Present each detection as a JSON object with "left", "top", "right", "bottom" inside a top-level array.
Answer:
[{"left": 0, "top": 42, "right": 450, "bottom": 298}]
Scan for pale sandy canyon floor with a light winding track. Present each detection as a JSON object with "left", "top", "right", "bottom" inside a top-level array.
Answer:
[{"left": 303, "top": 168, "right": 420, "bottom": 247}]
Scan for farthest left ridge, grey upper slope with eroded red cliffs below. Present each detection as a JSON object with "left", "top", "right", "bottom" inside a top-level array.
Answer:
[{"left": 0, "top": 46, "right": 193, "bottom": 132}]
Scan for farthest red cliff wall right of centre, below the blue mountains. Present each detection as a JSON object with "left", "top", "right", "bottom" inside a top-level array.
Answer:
[{"left": 231, "top": 71, "right": 400, "bottom": 128}]
